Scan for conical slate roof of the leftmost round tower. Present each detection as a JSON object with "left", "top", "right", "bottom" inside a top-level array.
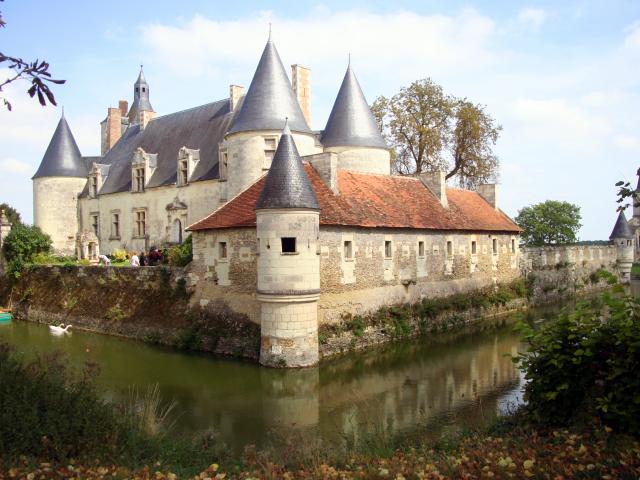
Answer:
[{"left": 33, "top": 115, "right": 87, "bottom": 178}]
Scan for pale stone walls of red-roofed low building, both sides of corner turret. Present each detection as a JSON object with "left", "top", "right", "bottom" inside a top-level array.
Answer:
[{"left": 188, "top": 226, "right": 520, "bottom": 324}]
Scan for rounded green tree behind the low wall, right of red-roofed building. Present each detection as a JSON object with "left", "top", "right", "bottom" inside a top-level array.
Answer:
[{"left": 515, "top": 200, "right": 582, "bottom": 246}]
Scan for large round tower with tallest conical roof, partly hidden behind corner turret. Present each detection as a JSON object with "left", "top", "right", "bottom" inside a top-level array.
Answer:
[{"left": 221, "top": 38, "right": 322, "bottom": 199}]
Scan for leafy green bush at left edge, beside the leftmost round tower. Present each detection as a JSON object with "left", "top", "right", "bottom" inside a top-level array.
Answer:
[{"left": 2, "top": 223, "right": 51, "bottom": 277}]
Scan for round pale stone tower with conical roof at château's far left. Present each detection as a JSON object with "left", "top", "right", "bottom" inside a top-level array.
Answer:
[{"left": 32, "top": 114, "right": 87, "bottom": 255}]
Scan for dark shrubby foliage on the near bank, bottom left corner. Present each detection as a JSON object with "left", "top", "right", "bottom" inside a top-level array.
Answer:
[{"left": 0, "top": 343, "right": 218, "bottom": 470}]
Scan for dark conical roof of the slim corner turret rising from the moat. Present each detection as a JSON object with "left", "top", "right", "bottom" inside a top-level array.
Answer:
[{"left": 256, "top": 122, "right": 320, "bottom": 210}]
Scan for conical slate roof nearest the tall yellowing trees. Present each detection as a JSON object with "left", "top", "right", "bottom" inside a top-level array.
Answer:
[{"left": 321, "top": 65, "right": 388, "bottom": 148}]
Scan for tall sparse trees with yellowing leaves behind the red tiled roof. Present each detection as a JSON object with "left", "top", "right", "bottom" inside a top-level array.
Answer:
[{"left": 371, "top": 78, "right": 502, "bottom": 188}]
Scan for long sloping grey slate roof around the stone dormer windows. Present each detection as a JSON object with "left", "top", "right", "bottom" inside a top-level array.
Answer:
[{"left": 95, "top": 99, "right": 233, "bottom": 194}]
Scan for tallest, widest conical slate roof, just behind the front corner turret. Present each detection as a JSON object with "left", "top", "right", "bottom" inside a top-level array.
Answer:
[{"left": 229, "top": 39, "right": 310, "bottom": 133}]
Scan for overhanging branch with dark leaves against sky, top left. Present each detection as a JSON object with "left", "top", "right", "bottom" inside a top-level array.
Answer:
[{"left": 0, "top": 0, "right": 66, "bottom": 111}]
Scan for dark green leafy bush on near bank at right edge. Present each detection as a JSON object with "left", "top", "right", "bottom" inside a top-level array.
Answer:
[{"left": 517, "top": 288, "right": 640, "bottom": 435}]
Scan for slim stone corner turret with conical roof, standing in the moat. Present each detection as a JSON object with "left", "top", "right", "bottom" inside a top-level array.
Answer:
[{"left": 256, "top": 120, "right": 320, "bottom": 367}]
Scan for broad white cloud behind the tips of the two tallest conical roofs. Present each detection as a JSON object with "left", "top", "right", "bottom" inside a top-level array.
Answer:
[{"left": 142, "top": 9, "right": 495, "bottom": 83}]
